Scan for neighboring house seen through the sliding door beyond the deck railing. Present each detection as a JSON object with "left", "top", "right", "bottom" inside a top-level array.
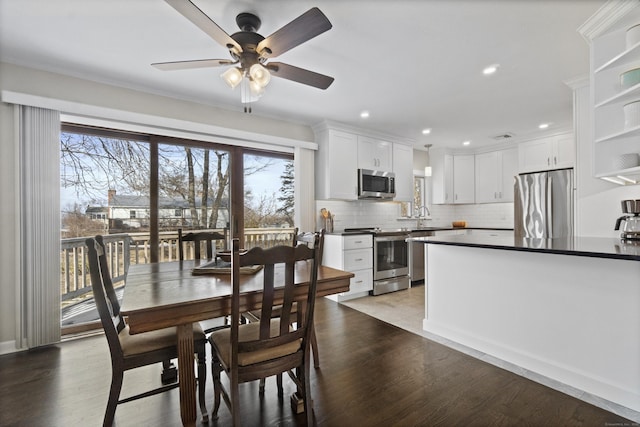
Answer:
[{"left": 85, "top": 190, "right": 229, "bottom": 233}]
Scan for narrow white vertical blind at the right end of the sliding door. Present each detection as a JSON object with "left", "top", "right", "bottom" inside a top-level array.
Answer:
[{"left": 293, "top": 147, "right": 316, "bottom": 231}]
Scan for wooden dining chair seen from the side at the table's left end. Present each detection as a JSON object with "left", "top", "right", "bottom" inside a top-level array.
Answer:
[{"left": 85, "top": 235, "right": 209, "bottom": 427}]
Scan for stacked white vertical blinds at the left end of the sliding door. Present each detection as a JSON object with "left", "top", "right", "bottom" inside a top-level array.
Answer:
[{"left": 17, "top": 106, "right": 60, "bottom": 348}]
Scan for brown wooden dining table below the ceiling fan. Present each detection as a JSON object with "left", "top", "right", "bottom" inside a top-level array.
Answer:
[{"left": 121, "top": 261, "right": 353, "bottom": 426}]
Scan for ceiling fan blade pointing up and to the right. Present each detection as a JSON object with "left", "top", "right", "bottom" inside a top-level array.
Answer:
[{"left": 256, "top": 7, "right": 332, "bottom": 58}]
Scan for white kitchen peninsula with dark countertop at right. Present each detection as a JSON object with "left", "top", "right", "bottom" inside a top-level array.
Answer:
[{"left": 413, "top": 235, "right": 640, "bottom": 421}]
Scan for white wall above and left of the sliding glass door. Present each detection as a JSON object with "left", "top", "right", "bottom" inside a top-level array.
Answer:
[{"left": 0, "top": 63, "right": 314, "bottom": 354}]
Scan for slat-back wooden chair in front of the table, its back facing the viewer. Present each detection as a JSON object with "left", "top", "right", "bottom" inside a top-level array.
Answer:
[{"left": 209, "top": 235, "right": 320, "bottom": 426}]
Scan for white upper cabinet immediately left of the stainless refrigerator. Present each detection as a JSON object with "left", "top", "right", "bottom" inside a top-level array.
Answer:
[{"left": 475, "top": 148, "right": 518, "bottom": 203}]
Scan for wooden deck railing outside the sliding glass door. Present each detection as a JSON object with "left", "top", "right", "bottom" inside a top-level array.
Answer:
[{"left": 60, "top": 228, "right": 294, "bottom": 307}]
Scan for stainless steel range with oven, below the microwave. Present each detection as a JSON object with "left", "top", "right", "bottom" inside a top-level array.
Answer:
[{"left": 345, "top": 228, "right": 411, "bottom": 295}]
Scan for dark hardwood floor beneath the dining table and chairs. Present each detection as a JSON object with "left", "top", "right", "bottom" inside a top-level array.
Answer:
[{"left": 0, "top": 299, "right": 633, "bottom": 427}]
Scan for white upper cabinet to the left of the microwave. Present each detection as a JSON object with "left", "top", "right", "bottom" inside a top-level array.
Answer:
[{"left": 315, "top": 129, "right": 358, "bottom": 200}]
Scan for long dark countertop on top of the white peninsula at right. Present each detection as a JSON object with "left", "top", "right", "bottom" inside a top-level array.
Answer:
[{"left": 411, "top": 235, "right": 640, "bottom": 261}]
